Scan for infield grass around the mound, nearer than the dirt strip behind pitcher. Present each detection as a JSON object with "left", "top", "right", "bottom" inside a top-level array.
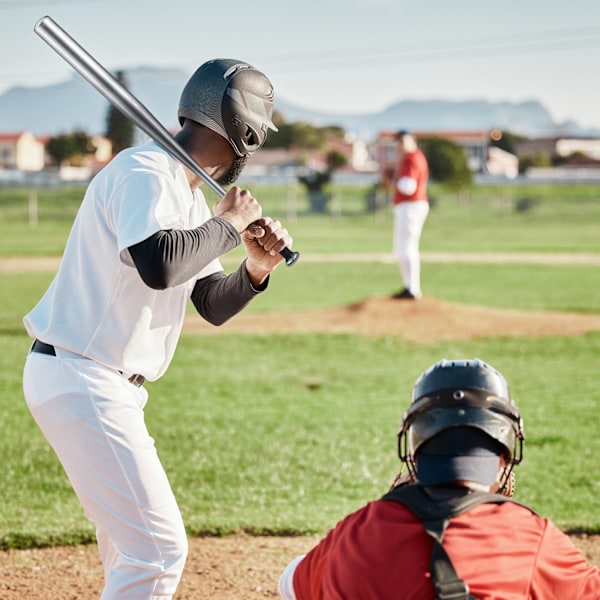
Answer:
[{"left": 0, "top": 263, "right": 600, "bottom": 548}]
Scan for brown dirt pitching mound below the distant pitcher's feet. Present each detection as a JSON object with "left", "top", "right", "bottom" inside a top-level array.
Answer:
[{"left": 184, "top": 297, "right": 600, "bottom": 342}]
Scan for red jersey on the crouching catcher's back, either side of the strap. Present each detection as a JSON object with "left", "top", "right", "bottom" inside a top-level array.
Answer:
[{"left": 293, "top": 500, "right": 600, "bottom": 600}]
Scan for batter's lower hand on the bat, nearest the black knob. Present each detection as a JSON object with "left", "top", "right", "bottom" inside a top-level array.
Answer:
[{"left": 242, "top": 217, "right": 293, "bottom": 280}]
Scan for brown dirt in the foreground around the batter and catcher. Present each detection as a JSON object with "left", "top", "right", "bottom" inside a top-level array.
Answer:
[{"left": 0, "top": 535, "right": 600, "bottom": 600}]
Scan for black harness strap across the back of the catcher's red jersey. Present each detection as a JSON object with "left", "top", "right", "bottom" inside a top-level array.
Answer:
[{"left": 382, "top": 484, "right": 527, "bottom": 600}]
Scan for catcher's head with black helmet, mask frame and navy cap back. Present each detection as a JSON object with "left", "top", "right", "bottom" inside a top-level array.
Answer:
[{"left": 398, "top": 359, "right": 524, "bottom": 493}]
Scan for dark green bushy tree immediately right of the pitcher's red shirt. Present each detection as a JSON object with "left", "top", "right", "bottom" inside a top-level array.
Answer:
[{"left": 419, "top": 137, "right": 473, "bottom": 191}]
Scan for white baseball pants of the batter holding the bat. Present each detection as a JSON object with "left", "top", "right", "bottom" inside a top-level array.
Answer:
[{"left": 23, "top": 349, "right": 187, "bottom": 600}]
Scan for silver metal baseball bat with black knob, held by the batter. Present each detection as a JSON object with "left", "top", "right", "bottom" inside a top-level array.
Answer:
[{"left": 33, "top": 16, "right": 300, "bottom": 267}]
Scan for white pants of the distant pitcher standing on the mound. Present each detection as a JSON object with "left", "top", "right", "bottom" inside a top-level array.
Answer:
[{"left": 393, "top": 200, "right": 429, "bottom": 298}]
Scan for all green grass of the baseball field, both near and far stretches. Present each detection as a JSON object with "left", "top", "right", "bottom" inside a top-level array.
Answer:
[{"left": 0, "top": 186, "right": 600, "bottom": 548}]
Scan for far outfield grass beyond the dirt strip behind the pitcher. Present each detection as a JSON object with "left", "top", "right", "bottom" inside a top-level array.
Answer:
[{"left": 0, "top": 184, "right": 600, "bottom": 256}]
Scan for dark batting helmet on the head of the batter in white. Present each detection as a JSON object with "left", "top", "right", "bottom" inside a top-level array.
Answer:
[{"left": 177, "top": 58, "right": 277, "bottom": 156}]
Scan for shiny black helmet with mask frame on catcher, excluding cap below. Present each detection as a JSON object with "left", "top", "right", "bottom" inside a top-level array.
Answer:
[{"left": 398, "top": 359, "right": 524, "bottom": 489}]
